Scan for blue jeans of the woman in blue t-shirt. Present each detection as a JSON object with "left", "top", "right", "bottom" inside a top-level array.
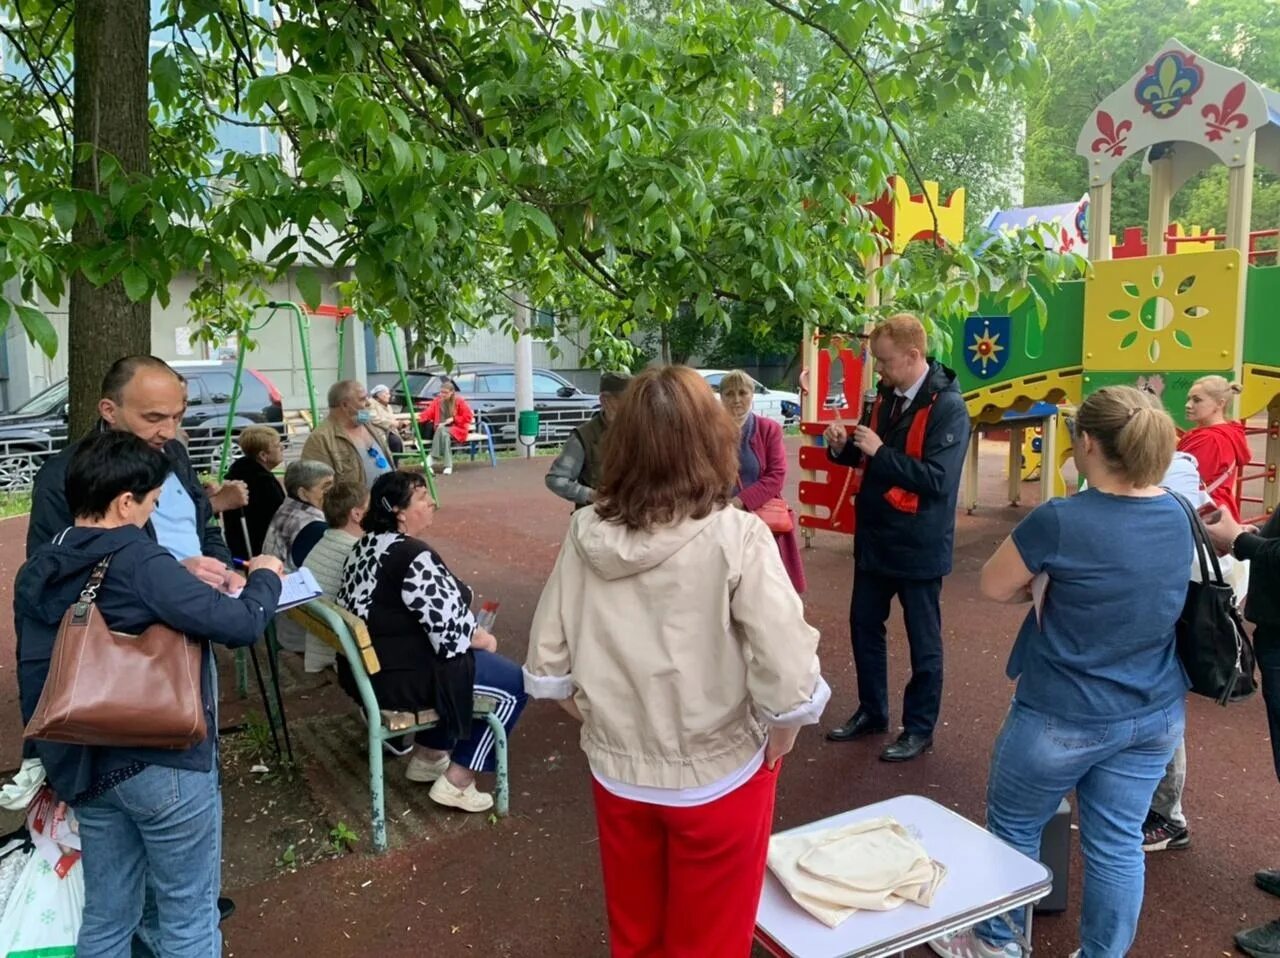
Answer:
[{"left": 978, "top": 699, "right": 1185, "bottom": 958}]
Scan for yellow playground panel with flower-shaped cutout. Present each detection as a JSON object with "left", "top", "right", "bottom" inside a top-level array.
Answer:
[{"left": 1084, "top": 250, "right": 1243, "bottom": 371}]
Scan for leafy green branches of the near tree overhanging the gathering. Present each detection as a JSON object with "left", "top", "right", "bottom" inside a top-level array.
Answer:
[{"left": 0, "top": 0, "right": 1079, "bottom": 407}]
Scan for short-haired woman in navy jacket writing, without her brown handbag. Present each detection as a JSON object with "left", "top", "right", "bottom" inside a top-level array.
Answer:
[{"left": 14, "top": 432, "right": 282, "bottom": 958}]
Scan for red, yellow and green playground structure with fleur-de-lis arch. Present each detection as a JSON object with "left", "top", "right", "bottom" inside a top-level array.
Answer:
[{"left": 800, "top": 40, "right": 1280, "bottom": 538}]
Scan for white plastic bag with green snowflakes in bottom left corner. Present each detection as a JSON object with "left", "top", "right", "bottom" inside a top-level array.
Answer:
[{"left": 0, "top": 854, "right": 84, "bottom": 958}]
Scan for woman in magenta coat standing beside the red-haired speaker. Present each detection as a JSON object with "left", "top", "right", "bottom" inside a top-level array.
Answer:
[{"left": 721, "top": 369, "right": 805, "bottom": 594}]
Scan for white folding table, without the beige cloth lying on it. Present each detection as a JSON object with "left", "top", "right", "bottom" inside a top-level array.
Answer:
[{"left": 755, "top": 795, "right": 1053, "bottom": 958}]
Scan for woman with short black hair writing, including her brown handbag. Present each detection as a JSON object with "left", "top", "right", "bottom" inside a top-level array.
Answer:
[{"left": 14, "top": 432, "right": 282, "bottom": 958}]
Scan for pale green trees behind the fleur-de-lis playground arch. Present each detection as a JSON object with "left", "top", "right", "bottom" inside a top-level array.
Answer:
[{"left": 1027, "top": 0, "right": 1280, "bottom": 232}]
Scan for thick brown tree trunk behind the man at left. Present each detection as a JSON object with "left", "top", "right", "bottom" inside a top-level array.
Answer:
[{"left": 67, "top": 0, "right": 151, "bottom": 437}]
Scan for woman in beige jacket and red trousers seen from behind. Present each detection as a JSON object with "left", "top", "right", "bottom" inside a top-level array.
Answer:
[{"left": 525, "top": 366, "right": 831, "bottom": 958}]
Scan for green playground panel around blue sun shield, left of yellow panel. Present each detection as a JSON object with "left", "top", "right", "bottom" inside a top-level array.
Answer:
[{"left": 947, "top": 282, "right": 1084, "bottom": 392}]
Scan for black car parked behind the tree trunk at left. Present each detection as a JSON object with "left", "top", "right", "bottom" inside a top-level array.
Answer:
[{"left": 0, "top": 362, "right": 285, "bottom": 489}]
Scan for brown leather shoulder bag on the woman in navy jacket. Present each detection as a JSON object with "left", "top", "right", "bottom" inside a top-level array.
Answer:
[{"left": 23, "top": 556, "right": 207, "bottom": 749}]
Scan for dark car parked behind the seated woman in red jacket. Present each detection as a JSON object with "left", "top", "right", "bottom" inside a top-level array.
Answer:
[{"left": 369, "top": 362, "right": 600, "bottom": 446}]
